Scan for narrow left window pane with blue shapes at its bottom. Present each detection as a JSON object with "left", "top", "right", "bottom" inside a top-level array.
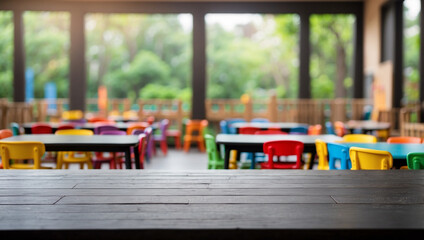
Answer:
[{"left": 24, "top": 12, "right": 70, "bottom": 99}]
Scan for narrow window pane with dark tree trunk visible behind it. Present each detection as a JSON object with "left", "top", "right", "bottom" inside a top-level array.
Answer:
[{"left": 310, "top": 14, "right": 355, "bottom": 98}]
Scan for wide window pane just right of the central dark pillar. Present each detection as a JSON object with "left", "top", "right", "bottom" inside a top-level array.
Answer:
[{"left": 206, "top": 14, "right": 299, "bottom": 99}]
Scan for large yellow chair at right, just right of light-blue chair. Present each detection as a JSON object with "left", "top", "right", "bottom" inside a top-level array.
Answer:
[{"left": 349, "top": 147, "right": 393, "bottom": 170}]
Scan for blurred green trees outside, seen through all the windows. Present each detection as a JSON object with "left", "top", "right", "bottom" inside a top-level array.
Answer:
[{"left": 0, "top": 4, "right": 419, "bottom": 102}]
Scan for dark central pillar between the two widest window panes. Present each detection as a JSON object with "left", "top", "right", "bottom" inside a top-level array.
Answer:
[{"left": 191, "top": 11, "right": 206, "bottom": 119}]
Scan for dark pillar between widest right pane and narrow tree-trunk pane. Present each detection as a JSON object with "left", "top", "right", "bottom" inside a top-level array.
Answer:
[{"left": 299, "top": 13, "right": 311, "bottom": 98}]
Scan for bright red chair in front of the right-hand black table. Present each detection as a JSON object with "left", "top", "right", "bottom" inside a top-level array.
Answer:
[{"left": 261, "top": 140, "right": 303, "bottom": 169}]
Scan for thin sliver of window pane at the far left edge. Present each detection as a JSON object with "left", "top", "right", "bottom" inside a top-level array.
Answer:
[{"left": 0, "top": 11, "right": 13, "bottom": 100}]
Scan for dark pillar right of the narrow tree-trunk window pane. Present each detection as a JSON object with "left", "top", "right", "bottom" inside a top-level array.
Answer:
[{"left": 353, "top": 3, "right": 368, "bottom": 98}]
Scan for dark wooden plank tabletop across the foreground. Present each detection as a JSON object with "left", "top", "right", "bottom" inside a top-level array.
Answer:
[{"left": 0, "top": 170, "right": 424, "bottom": 239}]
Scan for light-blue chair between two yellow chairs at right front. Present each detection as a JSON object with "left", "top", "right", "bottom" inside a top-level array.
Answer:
[{"left": 327, "top": 143, "right": 352, "bottom": 170}]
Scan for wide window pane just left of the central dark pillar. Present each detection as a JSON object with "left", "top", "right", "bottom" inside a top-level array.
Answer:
[{"left": 85, "top": 14, "right": 192, "bottom": 107}]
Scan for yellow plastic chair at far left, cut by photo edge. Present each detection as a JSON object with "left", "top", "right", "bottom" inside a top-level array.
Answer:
[{"left": 0, "top": 141, "right": 51, "bottom": 169}]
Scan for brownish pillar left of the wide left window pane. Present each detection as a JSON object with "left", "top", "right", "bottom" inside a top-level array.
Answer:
[{"left": 69, "top": 11, "right": 86, "bottom": 111}]
